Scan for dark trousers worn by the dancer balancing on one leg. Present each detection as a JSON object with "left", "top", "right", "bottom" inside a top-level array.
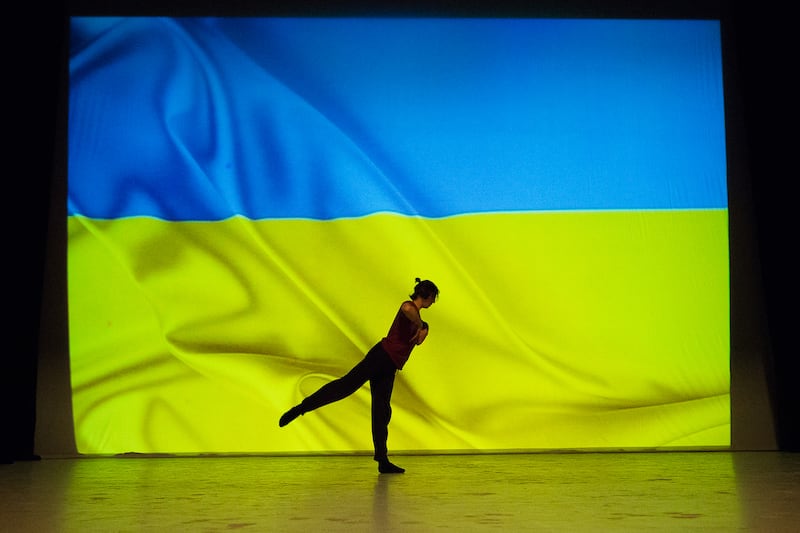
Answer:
[{"left": 300, "top": 343, "right": 397, "bottom": 461}]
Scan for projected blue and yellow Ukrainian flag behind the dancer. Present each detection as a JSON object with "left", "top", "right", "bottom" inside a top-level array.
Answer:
[{"left": 68, "top": 17, "right": 730, "bottom": 454}]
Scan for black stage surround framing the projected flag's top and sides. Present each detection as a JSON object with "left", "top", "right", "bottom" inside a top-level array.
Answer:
[{"left": 6, "top": 0, "right": 800, "bottom": 462}]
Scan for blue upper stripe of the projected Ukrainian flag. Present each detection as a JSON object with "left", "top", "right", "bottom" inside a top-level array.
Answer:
[{"left": 68, "top": 17, "right": 727, "bottom": 220}]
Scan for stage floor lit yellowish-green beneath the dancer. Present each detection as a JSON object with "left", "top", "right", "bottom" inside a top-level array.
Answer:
[{"left": 0, "top": 452, "right": 800, "bottom": 533}]
